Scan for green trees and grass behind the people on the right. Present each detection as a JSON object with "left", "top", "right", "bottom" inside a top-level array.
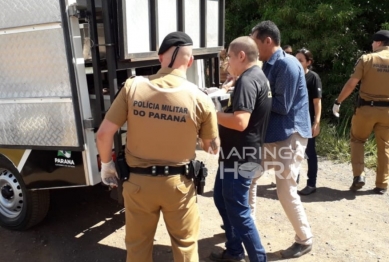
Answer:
[{"left": 226, "top": 0, "right": 389, "bottom": 166}]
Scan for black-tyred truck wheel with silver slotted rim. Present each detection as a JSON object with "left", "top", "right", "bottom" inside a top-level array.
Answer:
[{"left": 0, "top": 156, "right": 50, "bottom": 230}]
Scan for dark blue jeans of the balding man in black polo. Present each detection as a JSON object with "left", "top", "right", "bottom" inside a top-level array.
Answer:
[{"left": 213, "top": 167, "right": 267, "bottom": 262}]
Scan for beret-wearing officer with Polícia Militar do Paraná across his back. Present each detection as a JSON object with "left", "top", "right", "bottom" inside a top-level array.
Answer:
[{"left": 97, "top": 32, "right": 220, "bottom": 262}]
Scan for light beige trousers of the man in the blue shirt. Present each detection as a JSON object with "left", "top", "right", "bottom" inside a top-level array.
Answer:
[{"left": 263, "top": 133, "right": 312, "bottom": 245}]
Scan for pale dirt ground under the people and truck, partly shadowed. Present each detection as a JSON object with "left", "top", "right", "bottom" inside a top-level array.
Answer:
[{"left": 0, "top": 152, "right": 389, "bottom": 262}]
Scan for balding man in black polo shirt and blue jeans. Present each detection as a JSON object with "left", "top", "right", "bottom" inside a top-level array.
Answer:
[{"left": 210, "top": 37, "right": 271, "bottom": 262}]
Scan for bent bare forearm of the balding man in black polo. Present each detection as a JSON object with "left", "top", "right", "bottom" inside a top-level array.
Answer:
[{"left": 217, "top": 111, "right": 251, "bottom": 132}]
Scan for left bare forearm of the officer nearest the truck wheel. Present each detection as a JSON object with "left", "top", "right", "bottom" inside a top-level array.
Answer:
[{"left": 96, "top": 119, "right": 120, "bottom": 163}]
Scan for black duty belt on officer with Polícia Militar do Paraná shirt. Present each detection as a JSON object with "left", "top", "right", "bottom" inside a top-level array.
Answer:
[{"left": 130, "top": 165, "right": 189, "bottom": 176}]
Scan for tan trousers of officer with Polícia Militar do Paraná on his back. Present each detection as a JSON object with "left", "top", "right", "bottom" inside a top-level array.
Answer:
[{"left": 123, "top": 173, "right": 200, "bottom": 262}]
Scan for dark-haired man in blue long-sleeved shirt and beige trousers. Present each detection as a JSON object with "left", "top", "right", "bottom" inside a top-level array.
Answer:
[{"left": 251, "top": 21, "right": 312, "bottom": 258}]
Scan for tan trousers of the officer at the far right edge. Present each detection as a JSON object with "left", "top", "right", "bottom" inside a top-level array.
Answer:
[{"left": 350, "top": 106, "right": 389, "bottom": 188}]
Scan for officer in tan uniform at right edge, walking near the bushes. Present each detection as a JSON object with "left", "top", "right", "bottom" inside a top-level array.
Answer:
[{"left": 333, "top": 30, "right": 389, "bottom": 194}]
